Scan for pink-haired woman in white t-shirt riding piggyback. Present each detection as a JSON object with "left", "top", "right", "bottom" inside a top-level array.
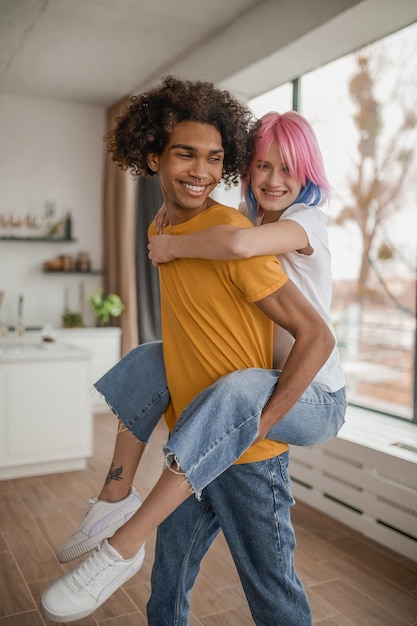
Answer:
[{"left": 42, "top": 106, "right": 346, "bottom": 620}]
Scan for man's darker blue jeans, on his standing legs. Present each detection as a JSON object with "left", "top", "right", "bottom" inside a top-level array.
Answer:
[{"left": 147, "top": 452, "right": 312, "bottom": 626}]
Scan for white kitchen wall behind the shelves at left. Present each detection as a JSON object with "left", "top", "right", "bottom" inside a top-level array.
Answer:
[{"left": 0, "top": 95, "right": 105, "bottom": 327}]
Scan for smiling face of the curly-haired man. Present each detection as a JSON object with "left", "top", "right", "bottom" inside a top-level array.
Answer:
[{"left": 148, "top": 121, "right": 224, "bottom": 224}]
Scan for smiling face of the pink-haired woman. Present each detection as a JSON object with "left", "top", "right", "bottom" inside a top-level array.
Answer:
[{"left": 251, "top": 141, "right": 302, "bottom": 220}]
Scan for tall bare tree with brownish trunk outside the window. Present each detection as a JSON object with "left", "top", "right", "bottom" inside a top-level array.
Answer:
[{"left": 335, "top": 43, "right": 417, "bottom": 310}]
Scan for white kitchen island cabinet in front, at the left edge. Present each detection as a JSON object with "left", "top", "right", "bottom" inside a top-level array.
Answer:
[{"left": 0, "top": 339, "right": 92, "bottom": 479}]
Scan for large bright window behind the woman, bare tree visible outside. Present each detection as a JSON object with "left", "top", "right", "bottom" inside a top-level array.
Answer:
[{"left": 250, "top": 25, "right": 417, "bottom": 421}]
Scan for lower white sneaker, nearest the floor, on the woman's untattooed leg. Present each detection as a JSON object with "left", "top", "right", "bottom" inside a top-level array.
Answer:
[{"left": 41, "top": 539, "right": 145, "bottom": 622}]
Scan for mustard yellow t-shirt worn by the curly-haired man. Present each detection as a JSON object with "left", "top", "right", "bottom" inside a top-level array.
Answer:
[{"left": 149, "top": 204, "right": 288, "bottom": 463}]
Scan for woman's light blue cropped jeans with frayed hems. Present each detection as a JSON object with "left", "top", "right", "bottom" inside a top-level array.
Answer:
[{"left": 95, "top": 341, "right": 346, "bottom": 497}]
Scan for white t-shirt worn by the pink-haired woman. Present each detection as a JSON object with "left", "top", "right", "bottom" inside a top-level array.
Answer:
[{"left": 274, "top": 204, "right": 346, "bottom": 391}]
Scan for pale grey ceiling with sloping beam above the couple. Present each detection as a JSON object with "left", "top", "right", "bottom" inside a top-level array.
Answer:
[{"left": 0, "top": 0, "right": 417, "bottom": 107}]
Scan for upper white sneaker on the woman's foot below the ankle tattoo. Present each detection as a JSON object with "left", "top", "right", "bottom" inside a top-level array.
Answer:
[{"left": 56, "top": 487, "right": 142, "bottom": 563}]
